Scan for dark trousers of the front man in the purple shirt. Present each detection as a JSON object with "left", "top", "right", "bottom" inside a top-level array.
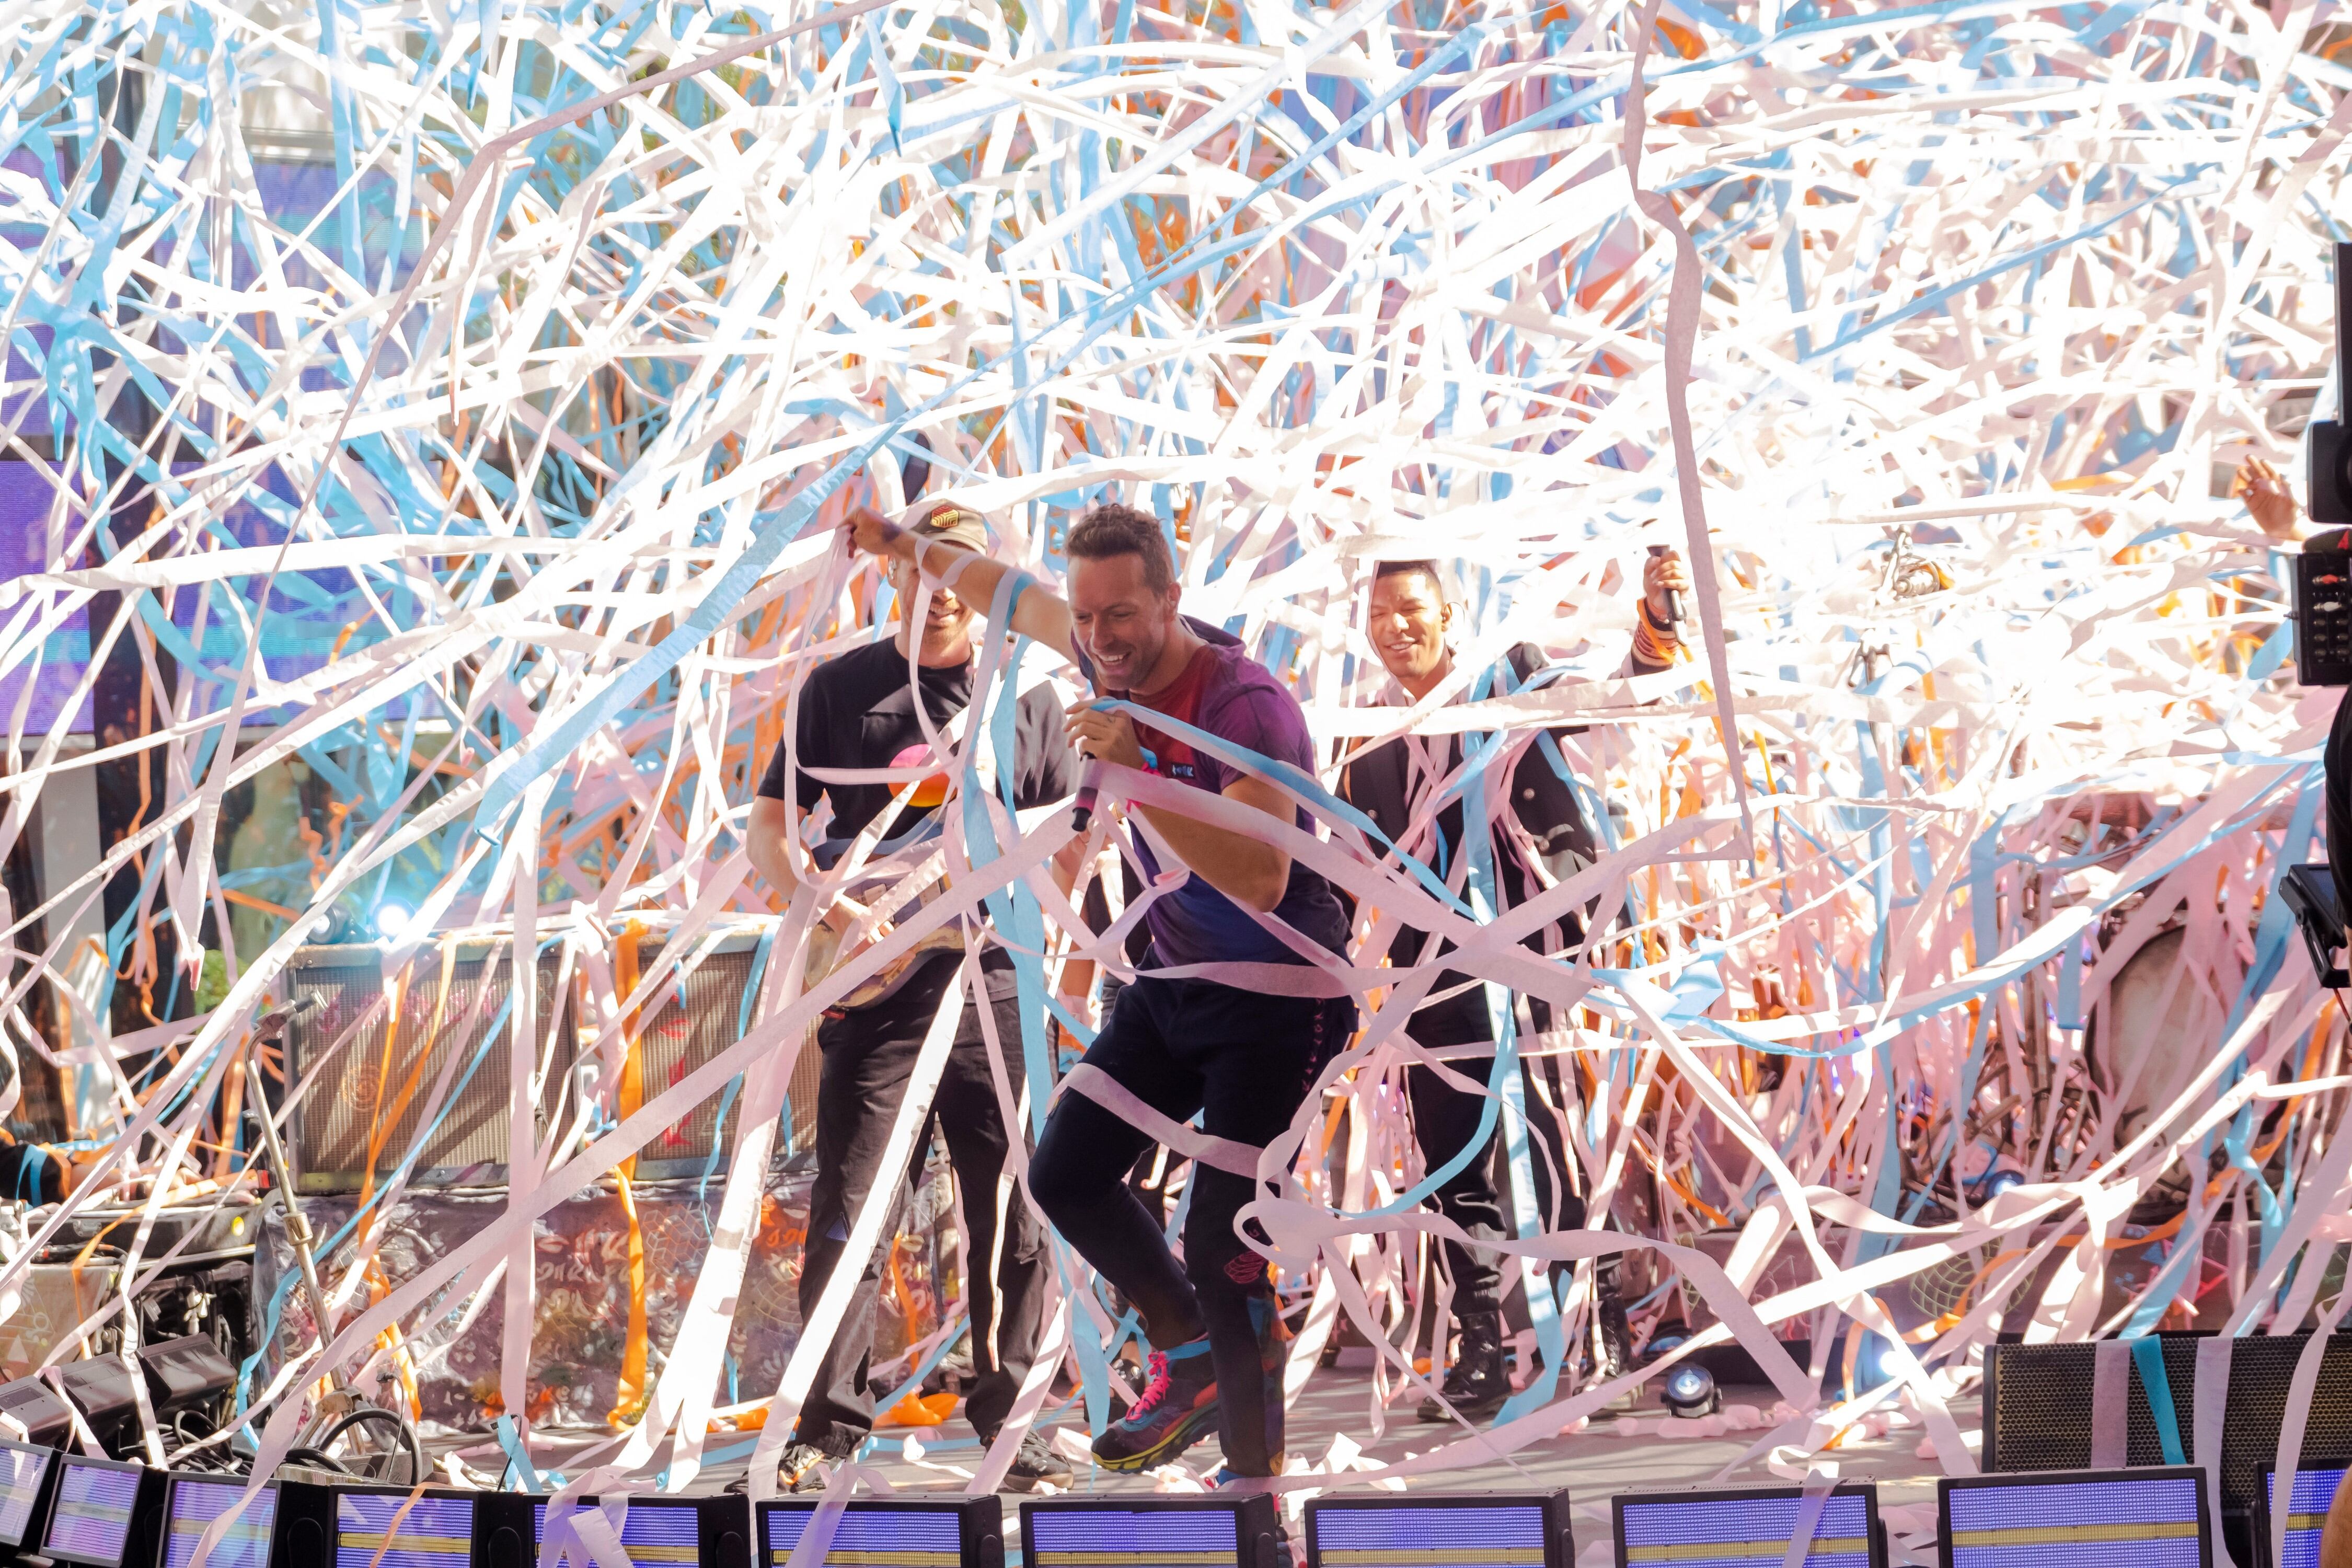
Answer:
[{"left": 1030, "top": 973, "right": 1355, "bottom": 1477}]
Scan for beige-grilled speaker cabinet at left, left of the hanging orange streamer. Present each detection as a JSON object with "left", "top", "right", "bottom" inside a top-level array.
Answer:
[{"left": 287, "top": 936, "right": 579, "bottom": 1192}]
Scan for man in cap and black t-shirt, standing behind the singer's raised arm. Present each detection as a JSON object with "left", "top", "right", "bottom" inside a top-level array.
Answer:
[{"left": 751, "top": 508, "right": 1077, "bottom": 1491}]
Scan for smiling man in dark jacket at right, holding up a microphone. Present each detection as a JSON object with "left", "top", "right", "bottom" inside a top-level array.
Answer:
[{"left": 1341, "top": 552, "right": 1691, "bottom": 1420}]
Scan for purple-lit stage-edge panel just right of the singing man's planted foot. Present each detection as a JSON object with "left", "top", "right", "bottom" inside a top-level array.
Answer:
[{"left": 1306, "top": 1491, "right": 1576, "bottom": 1568}]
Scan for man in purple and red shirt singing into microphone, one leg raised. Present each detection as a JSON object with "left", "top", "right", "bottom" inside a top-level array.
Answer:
[{"left": 851, "top": 505, "right": 1355, "bottom": 1477}]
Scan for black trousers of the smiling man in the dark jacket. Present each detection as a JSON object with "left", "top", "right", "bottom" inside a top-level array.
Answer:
[{"left": 1404, "top": 990, "right": 1616, "bottom": 1317}]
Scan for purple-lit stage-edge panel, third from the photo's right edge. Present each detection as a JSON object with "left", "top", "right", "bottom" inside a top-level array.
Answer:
[{"left": 1609, "top": 1481, "right": 1886, "bottom": 1568}]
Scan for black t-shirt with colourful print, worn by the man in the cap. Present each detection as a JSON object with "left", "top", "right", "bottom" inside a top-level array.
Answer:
[{"left": 760, "top": 642, "right": 1077, "bottom": 997}]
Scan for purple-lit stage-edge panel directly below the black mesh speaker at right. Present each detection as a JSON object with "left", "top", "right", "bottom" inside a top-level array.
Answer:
[{"left": 1936, "top": 1465, "right": 2213, "bottom": 1568}]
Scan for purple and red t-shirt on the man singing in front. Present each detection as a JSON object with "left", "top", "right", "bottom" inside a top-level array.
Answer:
[{"left": 1077, "top": 616, "right": 1348, "bottom": 969}]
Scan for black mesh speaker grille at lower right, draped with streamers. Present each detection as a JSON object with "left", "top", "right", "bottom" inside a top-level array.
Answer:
[{"left": 1985, "top": 1333, "right": 2352, "bottom": 1512}]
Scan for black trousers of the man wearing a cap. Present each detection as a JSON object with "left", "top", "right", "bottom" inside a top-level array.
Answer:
[{"left": 795, "top": 959, "right": 1052, "bottom": 1453}]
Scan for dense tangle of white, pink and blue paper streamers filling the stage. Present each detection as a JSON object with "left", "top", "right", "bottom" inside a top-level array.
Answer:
[{"left": 0, "top": 0, "right": 2352, "bottom": 1514}]
